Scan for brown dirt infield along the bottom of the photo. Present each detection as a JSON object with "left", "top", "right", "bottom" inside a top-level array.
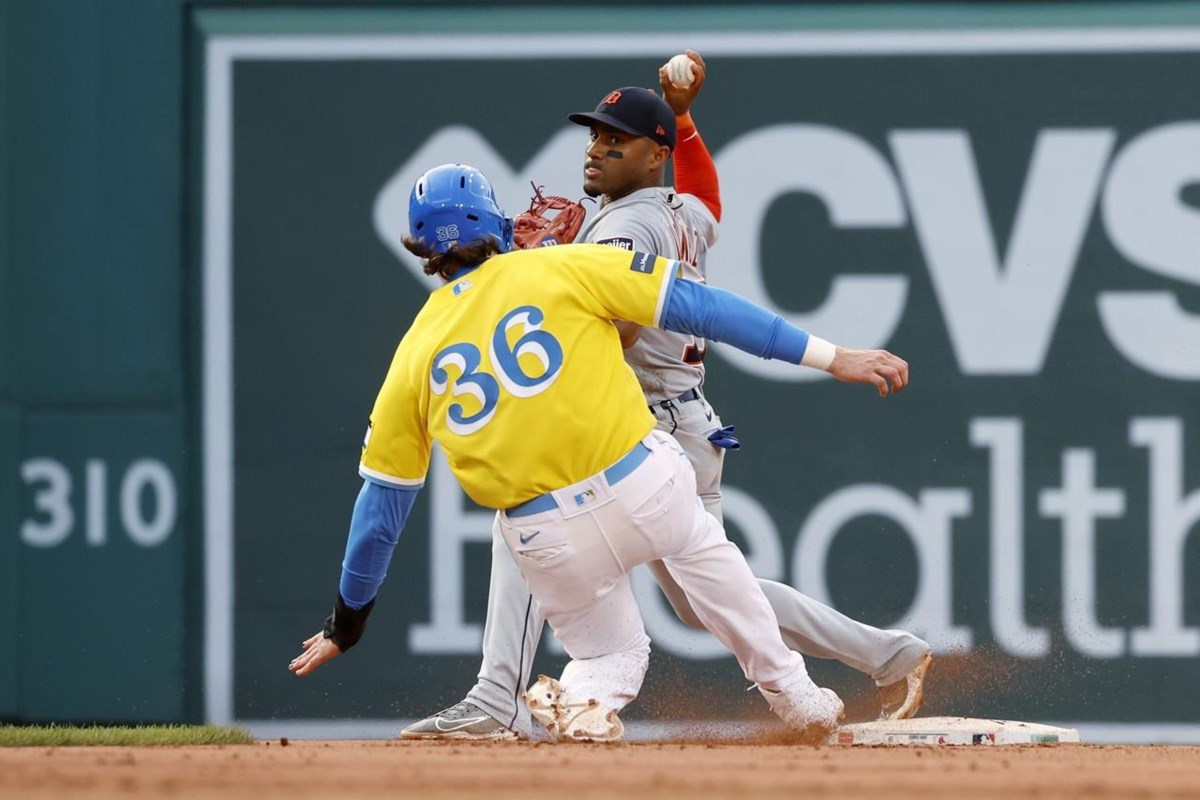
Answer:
[{"left": 0, "top": 740, "right": 1200, "bottom": 800}]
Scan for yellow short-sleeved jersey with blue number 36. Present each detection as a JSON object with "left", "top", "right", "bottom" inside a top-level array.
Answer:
[{"left": 359, "top": 245, "right": 678, "bottom": 509}]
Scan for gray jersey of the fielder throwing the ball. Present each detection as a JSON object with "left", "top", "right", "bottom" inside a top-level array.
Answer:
[{"left": 575, "top": 186, "right": 716, "bottom": 403}]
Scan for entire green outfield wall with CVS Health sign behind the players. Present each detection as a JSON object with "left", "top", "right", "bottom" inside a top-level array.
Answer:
[{"left": 0, "top": 0, "right": 1200, "bottom": 739}]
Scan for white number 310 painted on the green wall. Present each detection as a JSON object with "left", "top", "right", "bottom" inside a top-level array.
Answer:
[{"left": 20, "top": 458, "right": 178, "bottom": 547}]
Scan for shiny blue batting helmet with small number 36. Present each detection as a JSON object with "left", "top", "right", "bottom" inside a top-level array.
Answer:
[{"left": 408, "top": 164, "right": 512, "bottom": 254}]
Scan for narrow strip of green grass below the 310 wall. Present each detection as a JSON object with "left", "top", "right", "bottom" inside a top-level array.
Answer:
[{"left": 0, "top": 724, "right": 254, "bottom": 747}]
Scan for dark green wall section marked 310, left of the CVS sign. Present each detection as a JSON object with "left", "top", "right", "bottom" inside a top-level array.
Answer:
[{"left": 0, "top": 1, "right": 192, "bottom": 721}]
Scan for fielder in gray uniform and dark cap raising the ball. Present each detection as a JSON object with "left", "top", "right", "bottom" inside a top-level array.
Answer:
[{"left": 401, "top": 50, "right": 932, "bottom": 740}]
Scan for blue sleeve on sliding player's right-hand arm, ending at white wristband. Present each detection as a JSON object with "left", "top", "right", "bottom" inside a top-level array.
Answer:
[{"left": 661, "top": 281, "right": 809, "bottom": 363}]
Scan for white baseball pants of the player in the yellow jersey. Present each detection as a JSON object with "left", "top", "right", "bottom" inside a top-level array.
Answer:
[{"left": 500, "top": 431, "right": 816, "bottom": 710}]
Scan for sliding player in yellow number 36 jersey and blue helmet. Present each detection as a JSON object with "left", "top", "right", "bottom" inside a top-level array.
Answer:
[{"left": 289, "top": 164, "right": 908, "bottom": 741}]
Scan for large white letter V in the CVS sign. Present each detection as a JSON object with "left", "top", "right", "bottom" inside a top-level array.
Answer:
[{"left": 890, "top": 130, "right": 1115, "bottom": 375}]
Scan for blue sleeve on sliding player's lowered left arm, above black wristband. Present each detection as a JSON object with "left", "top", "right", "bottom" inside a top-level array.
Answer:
[{"left": 338, "top": 481, "right": 419, "bottom": 609}]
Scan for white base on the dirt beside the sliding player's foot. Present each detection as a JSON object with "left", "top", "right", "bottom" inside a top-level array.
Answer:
[{"left": 829, "top": 717, "right": 1079, "bottom": 746}]
